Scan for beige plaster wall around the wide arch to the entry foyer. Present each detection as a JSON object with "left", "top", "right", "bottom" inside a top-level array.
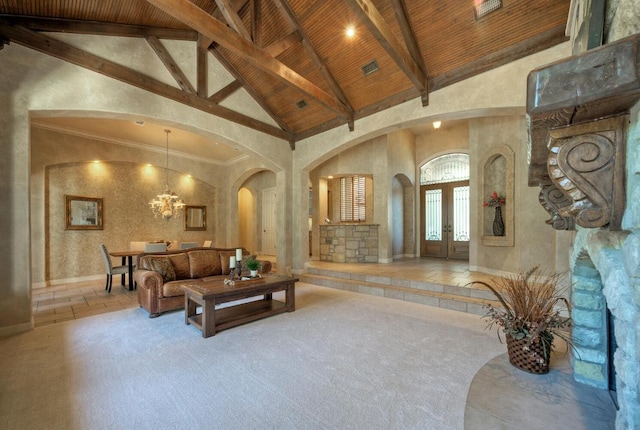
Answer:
[{"left": 291, "top": 42, "right": 571, "bottom": 271}]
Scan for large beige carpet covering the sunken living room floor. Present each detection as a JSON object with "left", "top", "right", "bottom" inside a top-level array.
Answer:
[{"left": 0, "top": 283, "right": 505, "bottom": 430}]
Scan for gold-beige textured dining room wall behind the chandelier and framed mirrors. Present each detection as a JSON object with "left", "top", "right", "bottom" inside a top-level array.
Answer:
[{"left": 45, "top": 162, "right": 218, "bottom": 282}]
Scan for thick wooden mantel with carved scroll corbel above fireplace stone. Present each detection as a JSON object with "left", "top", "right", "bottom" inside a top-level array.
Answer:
[{"left": 527, "top": 34, "right": 640, "bottom": 230}]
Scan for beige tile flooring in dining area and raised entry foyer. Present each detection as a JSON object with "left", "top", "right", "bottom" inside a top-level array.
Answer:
[{"left": 32, "top": 256, "right": 491, "bottom": 327}]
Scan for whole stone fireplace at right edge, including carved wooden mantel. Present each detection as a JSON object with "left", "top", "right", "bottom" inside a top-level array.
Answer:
[{"left": 527, "top": 34, "right": 640, "bottom": 429}]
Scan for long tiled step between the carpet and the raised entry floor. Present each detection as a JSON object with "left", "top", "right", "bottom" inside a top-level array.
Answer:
[{"left": 299, "top": 268, "right": 500, "bottom": 315}]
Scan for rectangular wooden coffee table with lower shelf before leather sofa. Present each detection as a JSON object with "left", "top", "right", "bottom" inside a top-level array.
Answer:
[{"left": 182, "top": 274, "right": 298, "bottom": 337}]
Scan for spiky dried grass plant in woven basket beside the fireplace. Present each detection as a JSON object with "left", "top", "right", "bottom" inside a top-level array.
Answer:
[{"left": 471, "top": 266, "right": 571, "bottom": 374}]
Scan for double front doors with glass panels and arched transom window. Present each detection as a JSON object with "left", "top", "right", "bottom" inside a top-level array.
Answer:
[{"left": 420, "top": 153, "right": 469, "bottom": 260}]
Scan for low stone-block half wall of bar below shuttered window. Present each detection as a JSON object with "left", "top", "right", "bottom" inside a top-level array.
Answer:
[{"left": 320, "top": 224, "right": 378, "bottom": 263}]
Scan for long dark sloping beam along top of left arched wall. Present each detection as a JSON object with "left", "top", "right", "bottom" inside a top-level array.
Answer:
[{"left": 0, "top": 19, "right": 292, "bottom": 141}]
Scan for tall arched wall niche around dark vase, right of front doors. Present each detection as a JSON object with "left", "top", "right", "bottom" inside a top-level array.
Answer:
[{"left": 478, "top": 145, "right": 515, "bottom": 246}]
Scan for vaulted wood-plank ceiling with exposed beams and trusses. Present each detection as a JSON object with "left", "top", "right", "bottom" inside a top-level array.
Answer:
[{"left": 0, "top": 0, "right": 570, "bottom": 148}]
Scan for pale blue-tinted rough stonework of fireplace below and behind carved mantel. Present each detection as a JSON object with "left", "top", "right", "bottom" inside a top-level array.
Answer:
[{"left": 571, "top": 103, "right": 640, "bottom": 430}]
